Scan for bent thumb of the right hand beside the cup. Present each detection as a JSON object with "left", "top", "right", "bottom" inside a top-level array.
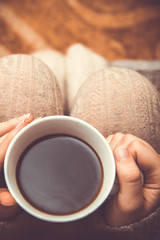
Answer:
[{"left": 114, "top": 147, "right": 144, "bottom": 212}]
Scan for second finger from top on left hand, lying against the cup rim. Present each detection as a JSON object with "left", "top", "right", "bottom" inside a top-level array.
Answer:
[{"left": 0, "top": 120, "right": 28, "bottom": 170}]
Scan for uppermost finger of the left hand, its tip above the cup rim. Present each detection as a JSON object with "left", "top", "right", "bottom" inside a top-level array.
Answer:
[{"left": 0, "top": 113, "right": 33, "bottom": 136}]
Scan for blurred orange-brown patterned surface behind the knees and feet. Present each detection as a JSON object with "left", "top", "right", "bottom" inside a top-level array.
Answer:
[{"left": 0, "top": 0, "right": 160, "bottom": 60}]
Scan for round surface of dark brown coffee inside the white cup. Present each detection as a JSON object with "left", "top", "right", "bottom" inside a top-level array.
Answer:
[{"left": 17, "top": 135, "right": 103, "bottom": 215}]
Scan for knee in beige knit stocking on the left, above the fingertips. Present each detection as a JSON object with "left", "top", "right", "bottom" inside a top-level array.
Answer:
[{"left": 0, "top": 54, "right": 63, "bottom": 122}]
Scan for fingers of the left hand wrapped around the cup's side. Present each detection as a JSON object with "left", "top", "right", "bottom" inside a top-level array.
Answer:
[{"left": 0, "top": 113, "right": 33, "bottom": 219}]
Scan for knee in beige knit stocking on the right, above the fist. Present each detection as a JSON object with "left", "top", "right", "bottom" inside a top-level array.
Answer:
[{"left": 70, "top": 67, "right": 160, "bottom": 152}]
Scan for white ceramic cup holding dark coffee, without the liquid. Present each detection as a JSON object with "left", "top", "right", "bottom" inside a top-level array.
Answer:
[{"left": 4, "top": 116, "right": 116, "bottom": 222}]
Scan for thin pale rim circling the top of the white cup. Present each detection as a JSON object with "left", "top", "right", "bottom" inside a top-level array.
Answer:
[{"left": 4, "top": 115, "right": 116, "bottom": 222}]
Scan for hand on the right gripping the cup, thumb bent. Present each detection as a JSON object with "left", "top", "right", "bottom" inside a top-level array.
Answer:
[{"left": 105, "top": 133, "right": 160, "bottom": 227}]
